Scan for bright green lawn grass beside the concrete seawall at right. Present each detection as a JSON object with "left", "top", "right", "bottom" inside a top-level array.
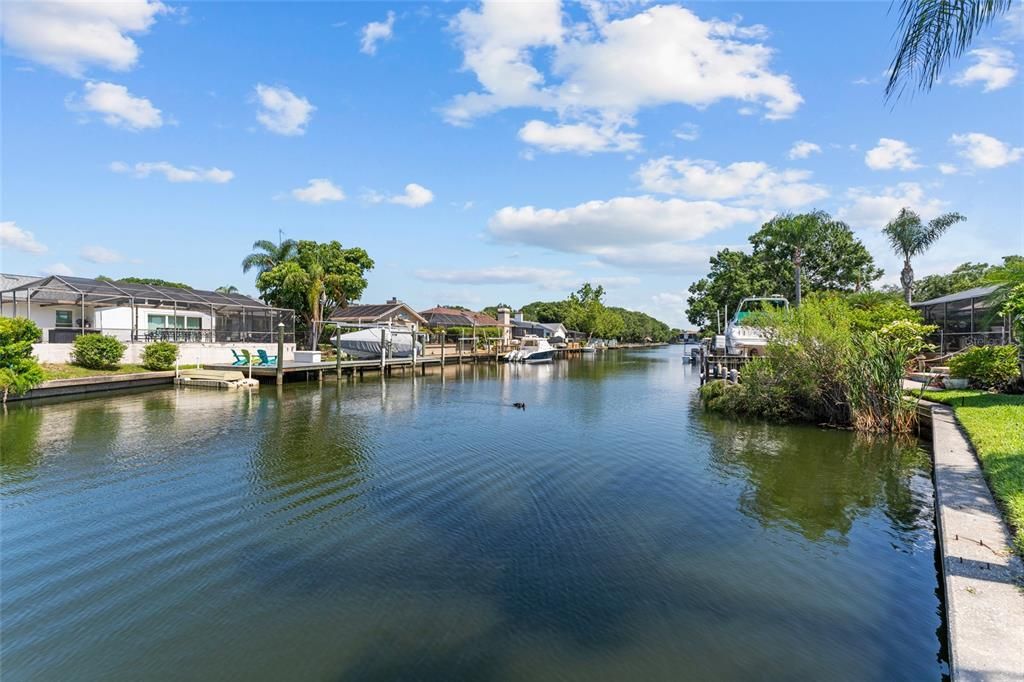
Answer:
[{"left": 925, "top": 390, "right": 1024, "bottom": 555}]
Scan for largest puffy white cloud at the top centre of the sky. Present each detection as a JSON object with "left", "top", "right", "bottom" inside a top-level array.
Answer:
[{"left": 443, "top": 0, "right": 803, "bottom": 137}]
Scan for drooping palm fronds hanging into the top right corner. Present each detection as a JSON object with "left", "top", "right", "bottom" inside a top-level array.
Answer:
[{"left": 886, "top": 0, "right": 1019, "bottom": 98}]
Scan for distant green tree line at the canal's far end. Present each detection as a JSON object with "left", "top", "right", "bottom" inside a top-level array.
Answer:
[{"left": 483, "top": 283, "right": 678, "bottom": 343}]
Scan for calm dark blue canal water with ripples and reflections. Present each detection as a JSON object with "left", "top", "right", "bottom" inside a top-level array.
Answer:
[{"left": 0, "top": 347, "right": 946, "bottom": 682}]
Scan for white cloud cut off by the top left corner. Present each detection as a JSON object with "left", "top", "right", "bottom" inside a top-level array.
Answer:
[{"left": 0, "top": 0, "right": 171, "bottom": 78}]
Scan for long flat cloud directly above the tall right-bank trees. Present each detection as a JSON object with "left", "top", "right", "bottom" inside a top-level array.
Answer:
[{"left": 637, "top": 157, "right": 828, "bottom": 209}]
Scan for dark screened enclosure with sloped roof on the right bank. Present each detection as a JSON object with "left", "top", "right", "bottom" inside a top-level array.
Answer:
[{"left": 910, "top": 287, "right": 1014, "bottom": 352}]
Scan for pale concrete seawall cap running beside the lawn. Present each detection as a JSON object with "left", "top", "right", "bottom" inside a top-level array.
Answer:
[{"left": 931, "top": 404, "right": 1024, "bottom": 682}]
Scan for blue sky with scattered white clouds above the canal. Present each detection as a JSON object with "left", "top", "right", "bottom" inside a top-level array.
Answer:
[{"left": 0, "top": 0, "right": 1024, "bottom": 326}]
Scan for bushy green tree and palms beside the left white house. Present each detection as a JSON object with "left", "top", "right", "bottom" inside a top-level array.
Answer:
[{"left": 242, "top": 240, "right": 374, "bottom": 348}]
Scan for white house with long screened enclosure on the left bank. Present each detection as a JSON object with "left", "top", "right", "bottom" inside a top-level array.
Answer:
[{"left": 0, "top": 274, "right": 295, "bottom": 364}]
